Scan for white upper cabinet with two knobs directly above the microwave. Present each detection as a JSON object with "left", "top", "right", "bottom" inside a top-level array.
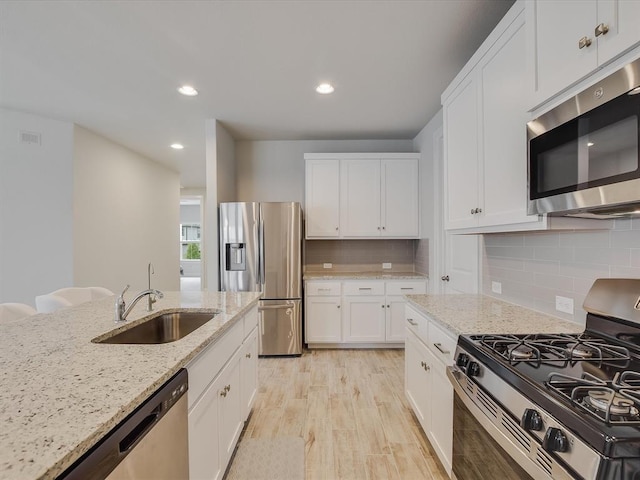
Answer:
[{"left": 527, "top": 0, "right": 640, "bottom": 108}]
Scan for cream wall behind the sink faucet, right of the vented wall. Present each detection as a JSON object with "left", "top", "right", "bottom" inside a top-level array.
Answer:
[{"left": 73, "top": 126, "right": 180, "bottom": 292}]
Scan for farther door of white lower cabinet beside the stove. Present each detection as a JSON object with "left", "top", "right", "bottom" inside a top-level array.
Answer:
[{"left": 404, "top": 329, "right": 431, "bottom": 432}]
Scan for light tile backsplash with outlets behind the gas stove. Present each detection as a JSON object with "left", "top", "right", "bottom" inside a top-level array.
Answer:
[{"left": 482, "top": 219, "right": 640, "bottom": 323}]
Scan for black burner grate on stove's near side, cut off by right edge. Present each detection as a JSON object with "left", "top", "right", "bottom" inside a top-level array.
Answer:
[{"left": 546, "top": 371, "right": 640, "bottom": 425}]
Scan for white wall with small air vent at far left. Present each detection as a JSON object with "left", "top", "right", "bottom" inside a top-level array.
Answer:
[{"left": 0, "top": 109, "right": 73, "bottom": 305}]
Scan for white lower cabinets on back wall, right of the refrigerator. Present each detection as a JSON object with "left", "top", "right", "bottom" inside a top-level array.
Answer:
[{"left": 304, "top": 279, "right": 427, "bottom": 347}]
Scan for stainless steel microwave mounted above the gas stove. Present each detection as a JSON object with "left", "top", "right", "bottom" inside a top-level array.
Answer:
[{"left": 527, "top": 55, "right": 640, "bottom": 218}]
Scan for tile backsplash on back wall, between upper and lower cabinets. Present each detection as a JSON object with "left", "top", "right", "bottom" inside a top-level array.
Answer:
[{"left": 304, "top": 240, "right": 415, "bottom": 272}]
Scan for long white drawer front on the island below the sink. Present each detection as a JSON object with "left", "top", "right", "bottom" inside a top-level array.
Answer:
[{"left": 187, "top": 320, "right": 244, "bottom": 409}]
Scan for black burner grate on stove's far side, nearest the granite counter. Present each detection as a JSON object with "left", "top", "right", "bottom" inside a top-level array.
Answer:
[{"left": 473, "top": 334, "right": 640, "bottom": 368}]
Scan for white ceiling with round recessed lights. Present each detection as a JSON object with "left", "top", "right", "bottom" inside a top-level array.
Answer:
[{"left": 0, "top": 0, "right": 513, "bottom": 187}]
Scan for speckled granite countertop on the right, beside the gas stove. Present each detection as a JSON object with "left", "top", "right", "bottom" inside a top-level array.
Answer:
[{"left": 406, "top": 294, "right": 584, "bottom": 335}]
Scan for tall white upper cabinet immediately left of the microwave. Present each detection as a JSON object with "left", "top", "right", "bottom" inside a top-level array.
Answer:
[{"left": 443, "top": 3, "right": 540, "bottom": 233}]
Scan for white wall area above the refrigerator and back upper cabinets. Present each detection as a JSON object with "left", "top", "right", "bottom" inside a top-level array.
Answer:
[{"left": 236, "top": 140, "right": 414, "bottom": 205}]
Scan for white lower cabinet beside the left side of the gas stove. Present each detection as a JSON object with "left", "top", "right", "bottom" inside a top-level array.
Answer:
[{"left": 405, "top": 306, "right": 456, "bottom": 475}]
